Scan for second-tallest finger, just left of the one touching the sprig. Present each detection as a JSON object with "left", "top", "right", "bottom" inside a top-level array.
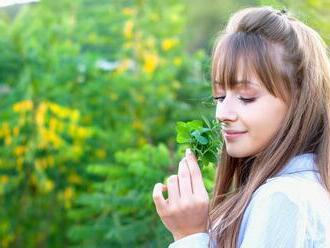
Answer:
[{"left": 178, "top": 158, "right": 192, "bottom": 198}]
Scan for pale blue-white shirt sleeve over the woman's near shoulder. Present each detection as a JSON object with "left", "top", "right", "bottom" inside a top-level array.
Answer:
[{"left": 239, "top": 175, "right": 330, "bottom": 247}]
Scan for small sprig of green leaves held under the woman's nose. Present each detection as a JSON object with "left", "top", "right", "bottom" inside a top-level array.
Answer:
[{"left": 176, "top": 116, "right": 222, "bottom": 167}]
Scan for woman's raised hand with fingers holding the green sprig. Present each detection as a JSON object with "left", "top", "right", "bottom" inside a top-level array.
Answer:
[{"left": 153, "top": 149, "right": 209, "bottom": 240}]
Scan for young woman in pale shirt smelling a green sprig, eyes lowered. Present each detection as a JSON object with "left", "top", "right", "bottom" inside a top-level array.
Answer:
[{"left": 153, "top": 7, "right": 330, "bottom": 248}]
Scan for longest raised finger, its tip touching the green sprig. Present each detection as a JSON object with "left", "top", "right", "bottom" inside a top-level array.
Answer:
[{"left": 186, "top": 149, "right": 206, "bottom": 194}]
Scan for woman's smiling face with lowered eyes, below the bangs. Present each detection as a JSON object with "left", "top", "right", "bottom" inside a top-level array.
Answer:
[{"left": 214, "top": 70, "right": 288, "bottom": 158}]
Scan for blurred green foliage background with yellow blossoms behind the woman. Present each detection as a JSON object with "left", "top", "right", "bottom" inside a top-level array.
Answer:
[{"left": 0, "top": 0, "right": 330, "bottom": 248}]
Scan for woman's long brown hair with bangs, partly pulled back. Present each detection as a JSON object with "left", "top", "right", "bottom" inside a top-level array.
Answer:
[{"left": 209, "top": 7, "right": 330, "bottom": 248}]
